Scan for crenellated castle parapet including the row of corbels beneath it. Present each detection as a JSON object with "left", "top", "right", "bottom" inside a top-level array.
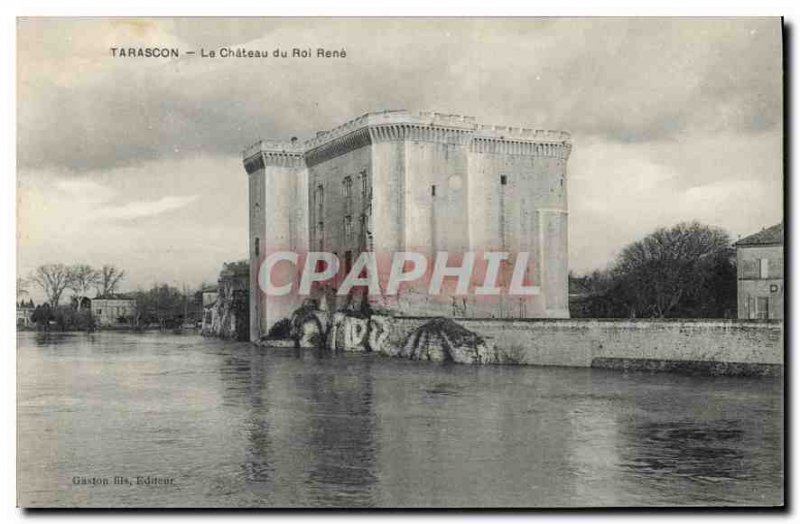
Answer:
[{"left": 243, "top": 110, "right": 572, "bottom": 173}]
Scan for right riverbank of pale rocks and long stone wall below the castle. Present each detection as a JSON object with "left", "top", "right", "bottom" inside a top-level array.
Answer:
[{"left": 260, "top": 312, "right": 784, "bottom": 376}]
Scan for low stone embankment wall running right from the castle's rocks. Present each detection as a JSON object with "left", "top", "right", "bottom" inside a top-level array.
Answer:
[{"left": 373, "top": 317, "right": 783, "bottom": 375}]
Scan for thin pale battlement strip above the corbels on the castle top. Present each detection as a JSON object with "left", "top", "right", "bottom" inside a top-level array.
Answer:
[{"left": 242, "top": 110, "right": 571, "bottom": 160}]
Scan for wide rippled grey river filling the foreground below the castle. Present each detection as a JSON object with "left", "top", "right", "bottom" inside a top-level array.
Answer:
[{"left": 17, "top": 332, "right": 783, "bottom": 508}]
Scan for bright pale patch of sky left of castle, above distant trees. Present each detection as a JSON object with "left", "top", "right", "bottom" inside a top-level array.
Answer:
[{"left": 17, "top": 156, "right": 247, "bottom": 289}]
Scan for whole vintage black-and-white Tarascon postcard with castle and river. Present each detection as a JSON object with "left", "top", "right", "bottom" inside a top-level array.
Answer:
[{"left": 16, "top": 18, "right": 786, "bottom": 509}]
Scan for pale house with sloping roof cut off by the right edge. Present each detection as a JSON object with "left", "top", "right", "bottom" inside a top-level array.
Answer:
[{"left": 733, "top": 222, "right": 784, "bottom": 320}]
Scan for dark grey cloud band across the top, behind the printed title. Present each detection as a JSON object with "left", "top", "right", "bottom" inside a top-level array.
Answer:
[{"left": 19, "top": 19, "right": 782, "bottom": 171}]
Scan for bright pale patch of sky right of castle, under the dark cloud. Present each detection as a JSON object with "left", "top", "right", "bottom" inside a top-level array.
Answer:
[{"left": 568, "top": 133, "right": 783, "bottom": 272}]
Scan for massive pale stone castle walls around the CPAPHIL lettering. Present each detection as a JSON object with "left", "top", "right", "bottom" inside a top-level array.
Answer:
[{"left": 243, "top": 111, "right": 572, "bottom": 340}]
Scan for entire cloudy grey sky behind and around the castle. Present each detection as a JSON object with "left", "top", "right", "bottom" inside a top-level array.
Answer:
[{"left": 17, "top": 19, "right": 783, "bottom": 296}]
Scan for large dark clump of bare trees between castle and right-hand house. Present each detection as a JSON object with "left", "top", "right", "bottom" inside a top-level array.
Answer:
[{"left": 570, "top": 222, "right": 737, "bottom": 318}]
